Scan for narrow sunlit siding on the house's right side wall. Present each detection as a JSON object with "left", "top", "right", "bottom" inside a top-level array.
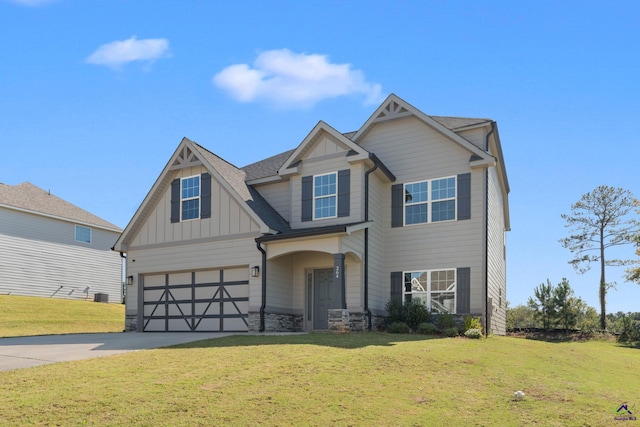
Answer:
[{"left": 487, "top": 168, "right": 507, "bottom": 335}]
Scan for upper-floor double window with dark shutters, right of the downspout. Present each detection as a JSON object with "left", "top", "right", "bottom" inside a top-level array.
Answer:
[{"left": 404, "top": 176, "right": 456, "bottom": 225}]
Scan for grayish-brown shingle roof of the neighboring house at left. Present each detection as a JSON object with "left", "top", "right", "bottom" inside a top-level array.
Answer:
[{"left": 0, "top": 182, "right": 122, "bottom": 232}]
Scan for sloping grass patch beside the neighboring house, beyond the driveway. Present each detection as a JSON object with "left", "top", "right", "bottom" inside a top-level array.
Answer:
[{"left": 0, "top": 295, "right": 124, "bottom": 338}]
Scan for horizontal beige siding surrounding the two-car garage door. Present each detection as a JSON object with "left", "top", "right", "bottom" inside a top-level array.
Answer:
[{"left": 126, "top": 238, "right": 262, "bottom": 315}]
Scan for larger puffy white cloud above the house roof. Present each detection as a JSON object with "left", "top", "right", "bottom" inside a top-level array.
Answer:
[{"left": 213, "top": 49, "right": 382, "bottom": 107}]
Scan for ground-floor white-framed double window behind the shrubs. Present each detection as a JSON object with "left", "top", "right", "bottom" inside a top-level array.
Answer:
[{"left": 403, "top": 268, "right": 456, "bottom": 314}]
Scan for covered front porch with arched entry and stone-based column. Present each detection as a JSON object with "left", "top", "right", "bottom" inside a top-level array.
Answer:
[{"left": 249, "top": 223, "right": 368, "bottom": 332}]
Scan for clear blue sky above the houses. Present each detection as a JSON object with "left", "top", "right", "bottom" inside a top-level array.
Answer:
[{"left": 0, "top": 0, "right": 640, "bottom": 312}]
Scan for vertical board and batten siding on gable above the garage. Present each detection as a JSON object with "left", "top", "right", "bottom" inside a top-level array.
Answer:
[{"left": 129, "top": 167, "right": 260, "bottom": 248}]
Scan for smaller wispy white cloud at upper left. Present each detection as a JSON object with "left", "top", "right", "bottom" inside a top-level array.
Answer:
[{"left": 85, "top": 36, "right": 169, "bottom": 68}]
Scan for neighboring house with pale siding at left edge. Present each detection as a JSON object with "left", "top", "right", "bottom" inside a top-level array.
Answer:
[{"left": 0, "top": 182, "right": 122, "bottom": 303}]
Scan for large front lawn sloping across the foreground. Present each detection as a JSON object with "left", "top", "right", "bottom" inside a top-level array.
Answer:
[{"left": 0, "top": 333, "right": 640, "bottom": 426}]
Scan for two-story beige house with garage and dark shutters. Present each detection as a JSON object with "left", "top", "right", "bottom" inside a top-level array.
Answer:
[{"left": 114, "top": 95, "right": 510, "bottom": 334}]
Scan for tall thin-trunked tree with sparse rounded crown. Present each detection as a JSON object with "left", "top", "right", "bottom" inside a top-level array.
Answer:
[{"left": 560, "top": 185, "right": 638, "bottom": 329}]
